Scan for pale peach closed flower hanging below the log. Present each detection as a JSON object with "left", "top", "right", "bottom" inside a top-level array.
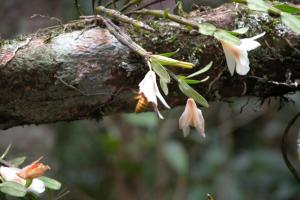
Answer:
[{"left": 179, "top": 98, "right": 205, "bottom": 138}]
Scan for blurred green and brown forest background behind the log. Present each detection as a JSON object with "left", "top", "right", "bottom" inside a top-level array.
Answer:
[{"left": 0, "top": 0, "right": 300, "bottom": 200}]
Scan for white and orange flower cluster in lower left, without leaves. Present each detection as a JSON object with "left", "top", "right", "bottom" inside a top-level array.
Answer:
[{"left": 0, "top": 158, "right": 50, "bottom": 194}]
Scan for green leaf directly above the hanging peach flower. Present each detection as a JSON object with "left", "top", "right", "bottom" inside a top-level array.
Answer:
[{"left": 179, "top": 79, "right": 208, "bottom": 108}]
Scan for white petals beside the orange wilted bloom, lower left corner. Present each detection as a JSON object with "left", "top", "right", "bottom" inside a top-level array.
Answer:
[{"left": 0, "top": 166, "right": 45, "bottom": 195}]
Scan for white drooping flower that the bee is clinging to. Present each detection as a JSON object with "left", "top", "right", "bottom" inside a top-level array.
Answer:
[{"left": 138, "top": 70, "right": 170, "bottom": 119}]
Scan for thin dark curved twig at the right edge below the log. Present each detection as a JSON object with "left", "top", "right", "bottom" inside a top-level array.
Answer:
[{"left": 281, "top": 112, "right": 300, "bottom": 183}]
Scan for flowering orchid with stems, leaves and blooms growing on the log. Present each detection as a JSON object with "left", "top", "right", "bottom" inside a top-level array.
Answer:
[{"left": 95, "top": 0, "right": 300, "bottom": 137}]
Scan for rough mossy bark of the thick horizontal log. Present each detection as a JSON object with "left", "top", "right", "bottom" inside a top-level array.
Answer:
[{"left": 0, "top": 4, "right": 300, "bottom": 129}]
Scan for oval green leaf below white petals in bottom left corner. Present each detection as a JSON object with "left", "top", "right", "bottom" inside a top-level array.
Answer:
[{"left": 0, "top": 181, "right": 27, "bottom": 197}]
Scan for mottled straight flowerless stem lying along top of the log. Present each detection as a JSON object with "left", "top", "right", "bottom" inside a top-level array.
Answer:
[{"left": 95, "top": 6, "right": 155, "bottom": 32}]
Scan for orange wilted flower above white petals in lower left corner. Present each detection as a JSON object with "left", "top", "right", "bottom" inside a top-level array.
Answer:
[{"left": 18, "top": 157, "right": 50, "bottom": 179}]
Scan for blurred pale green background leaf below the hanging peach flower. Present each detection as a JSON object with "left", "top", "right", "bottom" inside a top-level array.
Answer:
[{"left": 162, "top": 142, "right": 188, "bottom": 175}]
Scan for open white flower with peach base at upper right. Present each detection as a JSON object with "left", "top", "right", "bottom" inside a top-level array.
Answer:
[{"left": 221, "top": 33, "right": 265, "bottom": 75}]
